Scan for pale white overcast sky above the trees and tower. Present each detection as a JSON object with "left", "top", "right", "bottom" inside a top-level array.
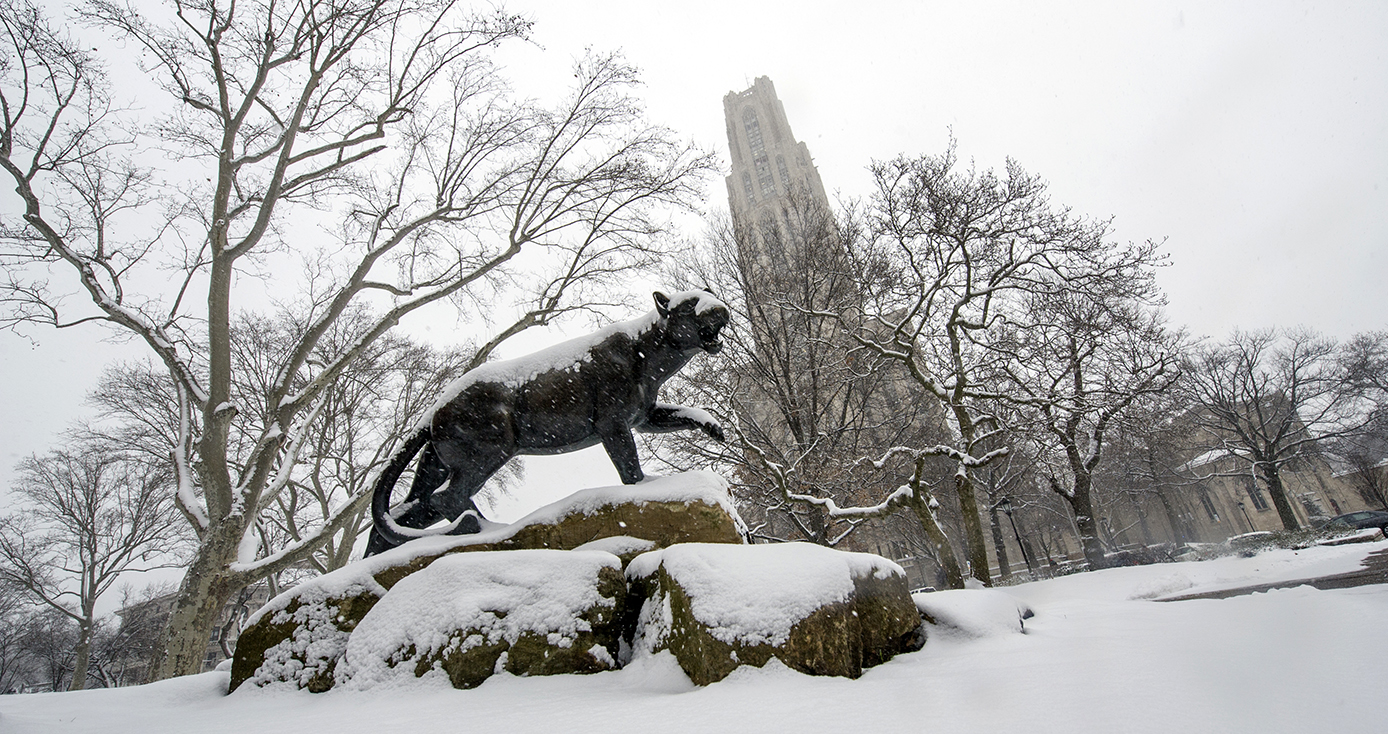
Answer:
[{"left": 0, "top": 0, "right": 1388, "bottom": 515}]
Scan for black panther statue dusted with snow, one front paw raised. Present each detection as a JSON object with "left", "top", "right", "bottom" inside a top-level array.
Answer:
[{"left": 366, "top": 290, "right": 729, "bottom": 555}]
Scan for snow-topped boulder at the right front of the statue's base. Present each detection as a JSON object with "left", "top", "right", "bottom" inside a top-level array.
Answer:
[{"left": 626, "top": 543, "right": 924, "bottom": 685}]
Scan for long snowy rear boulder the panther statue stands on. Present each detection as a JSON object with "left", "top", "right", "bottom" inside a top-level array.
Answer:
[{"left": 230, "top": 472, "right": 744, "bottom": 692}]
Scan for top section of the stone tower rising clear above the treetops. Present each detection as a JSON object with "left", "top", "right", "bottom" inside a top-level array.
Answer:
[{"left": 723, "top": 76, "right": 829, "bottom": 222}]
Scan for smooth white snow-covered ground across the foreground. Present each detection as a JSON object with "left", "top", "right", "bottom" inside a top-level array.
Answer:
[{"left": 0, "top": 541, "right": 1388, "bottom": 734}]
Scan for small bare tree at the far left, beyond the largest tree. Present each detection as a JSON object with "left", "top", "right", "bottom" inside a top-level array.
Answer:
[{"left": 0, "top": 450, "right": 180, "bottom": 690}]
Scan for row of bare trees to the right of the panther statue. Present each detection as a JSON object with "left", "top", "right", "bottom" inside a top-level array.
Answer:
[{"left": 657, "top": 143, "right": 1388, "bottom": 588}]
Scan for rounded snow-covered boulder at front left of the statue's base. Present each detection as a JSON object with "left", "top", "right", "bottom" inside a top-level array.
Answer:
[{"left": 336, "top": 551, "right": 626, "bottom": 688}]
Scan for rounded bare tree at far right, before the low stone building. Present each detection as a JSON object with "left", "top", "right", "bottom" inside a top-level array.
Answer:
[{"left": 1184, "top": 329, "right": 1371, "bottom": 530}]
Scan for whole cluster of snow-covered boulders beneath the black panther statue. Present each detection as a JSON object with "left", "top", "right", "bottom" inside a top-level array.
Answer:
[{"left": 230, "top": 472, "right": 924, "bottom": 692}]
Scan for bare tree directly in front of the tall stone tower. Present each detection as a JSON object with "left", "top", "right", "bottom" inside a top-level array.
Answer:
[{"left": 650, "top": 190, "right": 938, "bottom": 545}]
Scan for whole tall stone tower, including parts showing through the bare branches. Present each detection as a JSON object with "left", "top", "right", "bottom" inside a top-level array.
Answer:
[{"left": 723, "top": 76, "right": 942, "bottom": 586}]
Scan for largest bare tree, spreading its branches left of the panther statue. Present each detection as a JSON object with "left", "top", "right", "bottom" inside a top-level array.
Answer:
[{"left": 0, "top": 0, "right": 711, "bottom": 678}]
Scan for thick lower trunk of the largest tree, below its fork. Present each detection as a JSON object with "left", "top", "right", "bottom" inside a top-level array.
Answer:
[{"left": 147, "top": 520, "right": 244, "bottom": 683}]
